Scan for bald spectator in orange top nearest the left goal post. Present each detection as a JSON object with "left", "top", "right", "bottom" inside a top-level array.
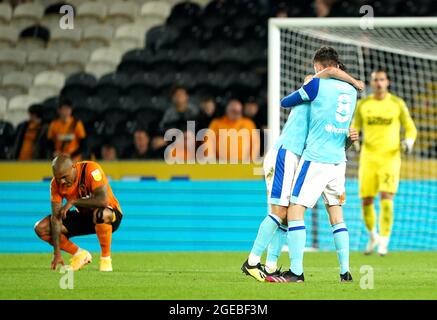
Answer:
[{"left": 207, "top": 99, "right": 260, "bottom": 161}]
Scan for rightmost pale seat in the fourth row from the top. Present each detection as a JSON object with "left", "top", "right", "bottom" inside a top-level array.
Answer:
[{"left": 29, "top": 71, "right": 65, "bottom": 99}]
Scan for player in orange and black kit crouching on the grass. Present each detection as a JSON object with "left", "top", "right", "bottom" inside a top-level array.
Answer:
[{"left": 35, "top": 155, "right": 123, "bottom": 271}]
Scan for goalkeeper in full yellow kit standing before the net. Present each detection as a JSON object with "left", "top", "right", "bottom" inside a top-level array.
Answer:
[{"left": 352, "top": 70, "right": 417, "bottom": 256}]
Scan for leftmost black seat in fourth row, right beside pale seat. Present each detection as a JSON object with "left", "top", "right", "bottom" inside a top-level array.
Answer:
[{"left": 61, "top": 72, "right": 97, "bottom": 102}]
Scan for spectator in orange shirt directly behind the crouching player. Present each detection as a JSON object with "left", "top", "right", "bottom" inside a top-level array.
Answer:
[{"left": 47, "top": 99, "right": 86, "bottom": 161}]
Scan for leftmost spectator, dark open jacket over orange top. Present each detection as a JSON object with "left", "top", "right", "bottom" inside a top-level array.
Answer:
[{"left": 13, "top": 104, "right": 48, "bottom": 160}]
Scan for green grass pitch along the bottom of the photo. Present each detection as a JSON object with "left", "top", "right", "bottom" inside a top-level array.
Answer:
[{"left": 0, "top": 252, "right": 437, "bottom": 300}]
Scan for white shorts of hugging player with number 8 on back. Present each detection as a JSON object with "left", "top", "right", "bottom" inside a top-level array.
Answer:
[{"left": 290, "top": 159, "right": 346, "bottom": 208}]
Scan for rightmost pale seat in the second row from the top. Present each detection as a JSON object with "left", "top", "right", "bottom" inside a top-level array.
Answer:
[{"left": 112, "top": 23, "right": 152, "bottom": 52}]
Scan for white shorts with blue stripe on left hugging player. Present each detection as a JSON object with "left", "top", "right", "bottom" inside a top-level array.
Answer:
[{"left": 263, "top": 147, "right": 300, "bottom": 207}]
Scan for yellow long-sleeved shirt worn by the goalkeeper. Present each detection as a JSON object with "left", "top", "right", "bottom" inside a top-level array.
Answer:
[{"left": 352, "top": 93, "right": 417, "bottom": 159}]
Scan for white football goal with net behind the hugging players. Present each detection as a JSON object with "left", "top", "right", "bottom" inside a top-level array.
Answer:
[{"left": 268, "top": 17, "right": 437, "bottom": 250}]
